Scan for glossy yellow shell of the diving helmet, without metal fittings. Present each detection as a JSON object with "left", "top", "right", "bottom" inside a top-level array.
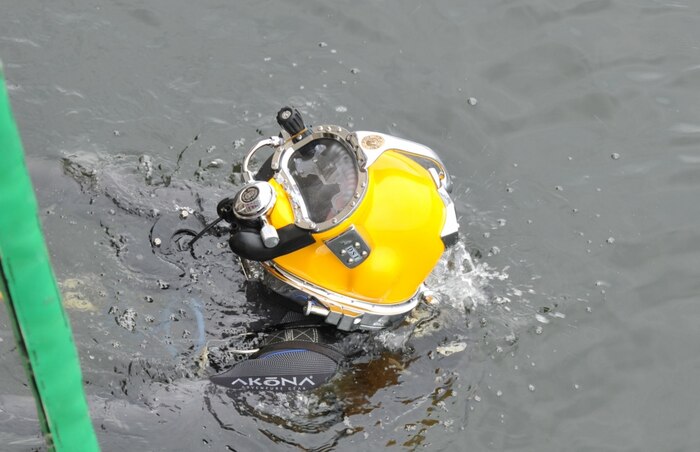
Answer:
[{"left": 268, "top": 150, "right": 447, "bottom": 305}]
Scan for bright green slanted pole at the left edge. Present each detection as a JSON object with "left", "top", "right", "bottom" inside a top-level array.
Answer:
[{"left": 0, "top": 63, "right": 99, "bottom": 452}]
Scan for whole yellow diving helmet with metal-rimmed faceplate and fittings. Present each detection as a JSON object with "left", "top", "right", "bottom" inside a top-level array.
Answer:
[{"left": 217, "top": 107, "right": 458, "bottom": 331}]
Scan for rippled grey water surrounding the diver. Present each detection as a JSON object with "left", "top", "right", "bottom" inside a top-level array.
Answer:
[{"left": 0, "top": 0, "right": 700, "bottom": 451}]
